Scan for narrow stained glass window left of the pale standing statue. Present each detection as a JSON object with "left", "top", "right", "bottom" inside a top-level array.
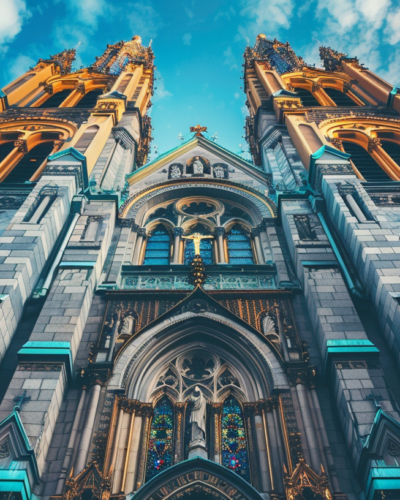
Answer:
[{"left": 146, "top": 397, "right": 174, "bottom": 481}]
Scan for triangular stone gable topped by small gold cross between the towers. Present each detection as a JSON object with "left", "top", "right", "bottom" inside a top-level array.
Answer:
[{"left": 127, "top": 136, "right": 266, "bottom": 185}]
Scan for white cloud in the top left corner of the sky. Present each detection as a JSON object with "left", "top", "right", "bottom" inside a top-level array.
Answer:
[{"left": 0, "top": 0, "right": 31, "bottom": 54}]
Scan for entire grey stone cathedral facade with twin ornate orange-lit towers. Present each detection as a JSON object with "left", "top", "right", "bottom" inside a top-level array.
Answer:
[{"left": 0, "top": 35, "right": 400, "bottom": 500}]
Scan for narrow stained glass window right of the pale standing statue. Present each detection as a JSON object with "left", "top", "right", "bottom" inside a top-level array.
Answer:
[{"left": 221, "top": 396, "right": 250, "bottom": 482}]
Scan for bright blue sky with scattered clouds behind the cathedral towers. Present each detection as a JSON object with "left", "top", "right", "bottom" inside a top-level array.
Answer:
[{"left": 0, "top": 0, "right": 400, "bottom": 157}]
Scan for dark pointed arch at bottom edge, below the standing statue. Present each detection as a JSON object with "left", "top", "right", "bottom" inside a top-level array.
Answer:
[{"left": 135, "top": 458, "right": 262, "bottom": 500}]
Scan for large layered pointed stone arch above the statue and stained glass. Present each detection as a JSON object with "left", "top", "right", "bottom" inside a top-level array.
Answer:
[{"left": 110, "top": 312, "right": 288, "bottom": 401}]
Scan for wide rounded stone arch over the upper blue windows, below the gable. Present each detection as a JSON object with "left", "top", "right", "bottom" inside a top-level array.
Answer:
[{"left": 120, "top": 179, "right": 276, "bottom": 224}]
